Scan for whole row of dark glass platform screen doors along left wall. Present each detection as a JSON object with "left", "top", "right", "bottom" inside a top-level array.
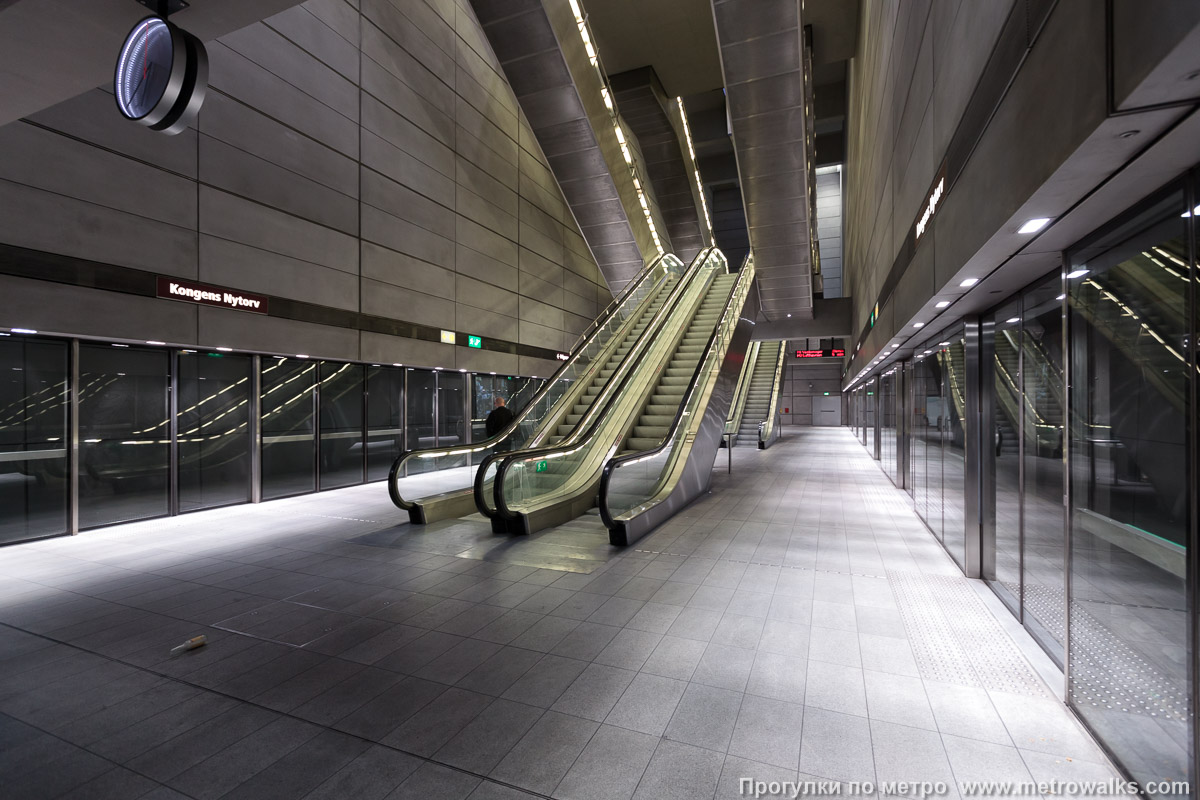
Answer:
[{"left": 0, "top": 332, "right": 546, "bottom": 545}]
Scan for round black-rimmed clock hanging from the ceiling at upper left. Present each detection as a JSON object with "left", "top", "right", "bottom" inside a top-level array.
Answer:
[{"left": 113, "top": 17, "right": 209, "bottom": 134}]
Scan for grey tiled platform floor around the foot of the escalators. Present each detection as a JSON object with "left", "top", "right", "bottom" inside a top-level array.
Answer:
[{"left": 0, "top": 428, "right": 1111, "bottom": 800}]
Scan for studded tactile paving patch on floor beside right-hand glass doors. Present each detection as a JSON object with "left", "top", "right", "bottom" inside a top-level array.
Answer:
[{"left": 888, "top": 572, "right": 1048, "bottom": 697}]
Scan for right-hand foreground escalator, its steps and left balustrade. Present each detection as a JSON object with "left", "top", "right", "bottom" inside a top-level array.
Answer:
[{"left": 475, "top": 248, "right": 754, "bottom": 543}]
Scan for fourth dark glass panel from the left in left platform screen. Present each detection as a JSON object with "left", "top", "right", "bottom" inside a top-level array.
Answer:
[{"left": 262, "top": 357, "right": 317, "bottom": 499}]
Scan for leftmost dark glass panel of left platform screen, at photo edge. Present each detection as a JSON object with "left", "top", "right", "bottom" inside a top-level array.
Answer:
[{"left": 0, "top": 337, "right": 68, "bottom": 543}]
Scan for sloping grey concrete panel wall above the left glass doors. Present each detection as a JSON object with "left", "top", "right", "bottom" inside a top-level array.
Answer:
[{"left": 0, "top": 0, "right": 611, "bottom": 374}]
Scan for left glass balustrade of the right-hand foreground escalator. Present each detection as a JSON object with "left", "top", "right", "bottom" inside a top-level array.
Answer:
[{"left": 480, "top": 248, "right": 727, "bottom": 534}]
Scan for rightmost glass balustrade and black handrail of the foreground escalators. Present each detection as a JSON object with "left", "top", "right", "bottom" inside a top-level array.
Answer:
[{"left": 599, "top": 257, "right": 755, "bottom": 547}]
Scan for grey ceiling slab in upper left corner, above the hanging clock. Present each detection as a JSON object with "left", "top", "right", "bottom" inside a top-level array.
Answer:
[{"left": 0, "top": 0, "right": 309, "bottom": 125}]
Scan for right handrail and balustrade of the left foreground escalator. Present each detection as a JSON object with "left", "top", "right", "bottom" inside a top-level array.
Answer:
[{"left": 473, "top": 248, "right": 719, "bottom": 527}]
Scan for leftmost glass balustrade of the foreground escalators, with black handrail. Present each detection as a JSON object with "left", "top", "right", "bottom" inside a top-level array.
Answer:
[{"left": 388, "top": 255, "right": 684, "bottom": 524}]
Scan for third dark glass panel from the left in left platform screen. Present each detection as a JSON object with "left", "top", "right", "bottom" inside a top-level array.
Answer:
[{"left": 176, "top": 353, "right": 251, "bottom": 512}]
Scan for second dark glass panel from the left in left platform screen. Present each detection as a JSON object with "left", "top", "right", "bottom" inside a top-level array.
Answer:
[{"left": 79, "top": 344, "right": 170, "bottom": 528}]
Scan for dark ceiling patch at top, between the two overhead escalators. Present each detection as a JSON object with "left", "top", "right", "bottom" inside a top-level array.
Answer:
[{"left": 582, "top": 0, "right": 722, "bottom": 97}]
